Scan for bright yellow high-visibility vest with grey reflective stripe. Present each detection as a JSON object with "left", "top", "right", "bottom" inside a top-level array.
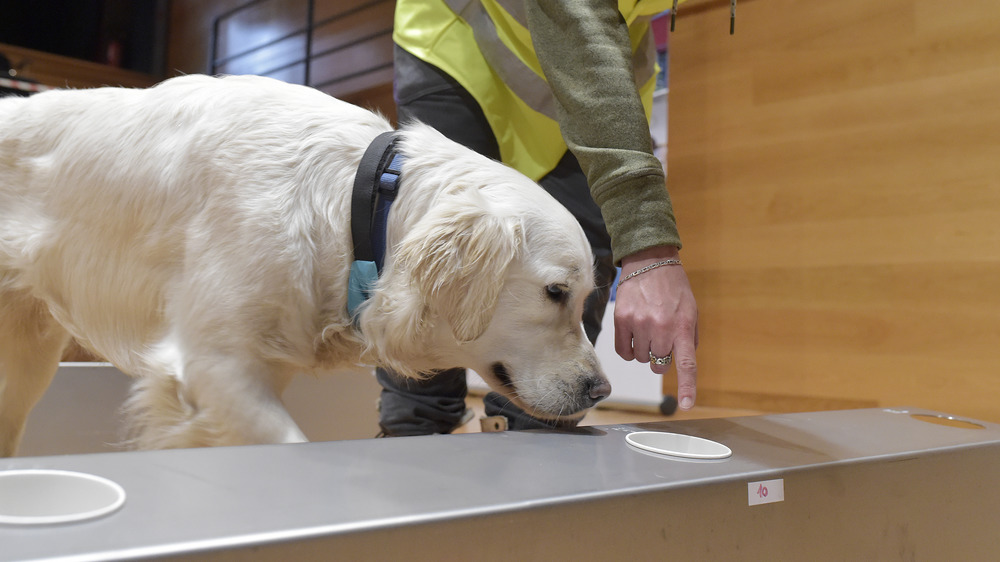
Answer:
[{"left": 393, "top": 0, "right": 672, "bottom": 181}]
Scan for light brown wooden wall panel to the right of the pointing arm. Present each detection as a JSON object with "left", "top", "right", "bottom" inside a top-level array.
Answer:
[{"left": 665, "top": 0, "right": 1000, "bottom": 421}]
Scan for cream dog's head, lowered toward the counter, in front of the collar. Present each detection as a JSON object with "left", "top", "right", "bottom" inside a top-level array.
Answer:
[{"left": 361, "top": 123, "right": 610, "bottom": 418}]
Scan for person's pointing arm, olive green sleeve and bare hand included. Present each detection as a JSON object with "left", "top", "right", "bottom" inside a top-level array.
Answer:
[{"left": 525, "top": 0, "right": 698, "bottom": 409}]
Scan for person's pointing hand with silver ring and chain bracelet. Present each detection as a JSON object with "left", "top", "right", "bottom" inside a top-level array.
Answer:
[{"left": 615, "top": 246, "right": 698, "bottom": 410}]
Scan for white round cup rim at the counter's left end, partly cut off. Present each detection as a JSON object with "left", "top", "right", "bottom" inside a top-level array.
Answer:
[{"left": 0, "top": 469, "right": 125, "bottom": 525}]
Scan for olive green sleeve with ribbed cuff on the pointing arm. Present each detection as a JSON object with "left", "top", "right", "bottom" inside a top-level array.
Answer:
[{"left": 525, "top": 0, "right": 680, "bottom": 263}]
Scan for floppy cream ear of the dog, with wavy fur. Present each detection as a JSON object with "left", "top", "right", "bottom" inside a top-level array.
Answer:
[{"left": 396, "top": 189, "right": 523, "bottom": 342}]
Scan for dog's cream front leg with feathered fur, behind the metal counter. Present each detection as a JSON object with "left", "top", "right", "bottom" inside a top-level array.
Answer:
[{"left": 126, "top": 355, "right": 307, "bottom": 449}]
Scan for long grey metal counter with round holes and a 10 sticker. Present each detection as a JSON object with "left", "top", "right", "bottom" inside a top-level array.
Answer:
[{"left": 0, "top": 408, "right": 1000, "bottom": 561}]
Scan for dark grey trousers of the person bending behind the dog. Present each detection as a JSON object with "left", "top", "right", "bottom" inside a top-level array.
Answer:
[{"left": 376, "top": 46, "right": 615, "bottom": 436}]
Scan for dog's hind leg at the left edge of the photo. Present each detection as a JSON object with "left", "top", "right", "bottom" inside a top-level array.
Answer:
[{"left": 0, "top": 292, "right": 70, "bottom": 457}]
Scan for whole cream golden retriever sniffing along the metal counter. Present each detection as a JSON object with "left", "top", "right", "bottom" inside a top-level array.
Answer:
[{"left": 0, "top": 76, "right": 610, "bottom": 456}]
